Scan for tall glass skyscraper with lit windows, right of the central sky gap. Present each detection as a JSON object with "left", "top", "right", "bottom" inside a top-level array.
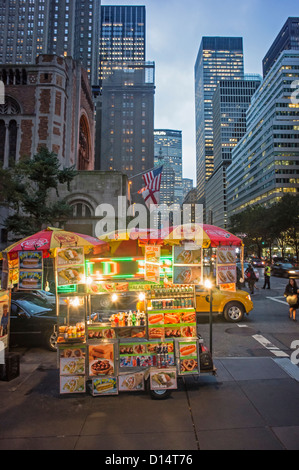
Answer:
[{"left": 194, "top": 37, "right": 244, "bottom": 205}]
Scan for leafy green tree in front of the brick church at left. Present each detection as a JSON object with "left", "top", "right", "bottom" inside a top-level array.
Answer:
[{"left": 0, "top": 147, "right": 77, "bottom": 238}]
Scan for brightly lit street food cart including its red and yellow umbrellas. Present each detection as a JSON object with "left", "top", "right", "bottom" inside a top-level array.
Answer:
[{"left": 1, "top": 224, "right": 242, "bottom": 399}]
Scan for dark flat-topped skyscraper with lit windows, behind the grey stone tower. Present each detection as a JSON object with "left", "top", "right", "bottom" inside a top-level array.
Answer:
[{"left": 99, "top": 5, "right": 146, "bottom": 84}]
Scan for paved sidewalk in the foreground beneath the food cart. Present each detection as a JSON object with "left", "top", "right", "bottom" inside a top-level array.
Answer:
[{"left": 0, "top": 357, "right": 299, "bottom": 455}]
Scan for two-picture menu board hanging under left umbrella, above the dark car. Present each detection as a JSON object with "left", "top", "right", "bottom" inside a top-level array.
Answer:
[{"left": 15, "top": 251, "right": 43, "bottom": 290}]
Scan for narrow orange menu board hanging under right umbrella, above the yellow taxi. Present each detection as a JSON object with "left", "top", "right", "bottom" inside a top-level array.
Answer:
[{"left": 217, "top": 246, "right": 237, "bottom": 290}]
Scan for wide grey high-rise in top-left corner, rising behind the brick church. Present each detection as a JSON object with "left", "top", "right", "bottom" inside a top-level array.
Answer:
[{"left": 0, "top": 0, "right": 101, "bottom": 85}]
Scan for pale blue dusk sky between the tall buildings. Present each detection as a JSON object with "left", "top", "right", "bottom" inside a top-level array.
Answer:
[{"left": 102, "top": 0, "right": 299, "bottom": 184}]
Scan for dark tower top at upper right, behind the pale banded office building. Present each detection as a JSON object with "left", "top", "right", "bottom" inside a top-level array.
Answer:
[{"left": 263, "top": 17, "right": 299, "bottom": 78}]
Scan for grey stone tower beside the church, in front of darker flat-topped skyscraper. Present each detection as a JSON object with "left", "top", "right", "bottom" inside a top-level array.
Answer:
[{"left": 100, "top": 62, "right": 155, "bottom": 197}]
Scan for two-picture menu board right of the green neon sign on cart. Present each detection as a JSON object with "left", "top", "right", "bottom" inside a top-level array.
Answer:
[{"left": 173, "top": 243, "right": 203, "bottom": 284}]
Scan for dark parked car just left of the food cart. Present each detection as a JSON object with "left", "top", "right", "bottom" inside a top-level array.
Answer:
[{"left": 10, "top": 298, "right": 57, "bottom": 351}]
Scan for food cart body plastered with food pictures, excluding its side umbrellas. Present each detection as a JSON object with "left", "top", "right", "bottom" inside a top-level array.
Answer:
[{"left": 58, "top": 226, "right": 232, "bottom": 399}]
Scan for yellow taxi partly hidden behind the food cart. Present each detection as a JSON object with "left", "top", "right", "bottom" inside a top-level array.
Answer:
[{"left": 196, "top": 286, "right": 253, "bottom": 323}]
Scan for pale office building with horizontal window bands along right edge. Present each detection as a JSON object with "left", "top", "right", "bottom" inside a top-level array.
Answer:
[{"left": 227, "top": 51, "right": 299, "bottom": 216}]
